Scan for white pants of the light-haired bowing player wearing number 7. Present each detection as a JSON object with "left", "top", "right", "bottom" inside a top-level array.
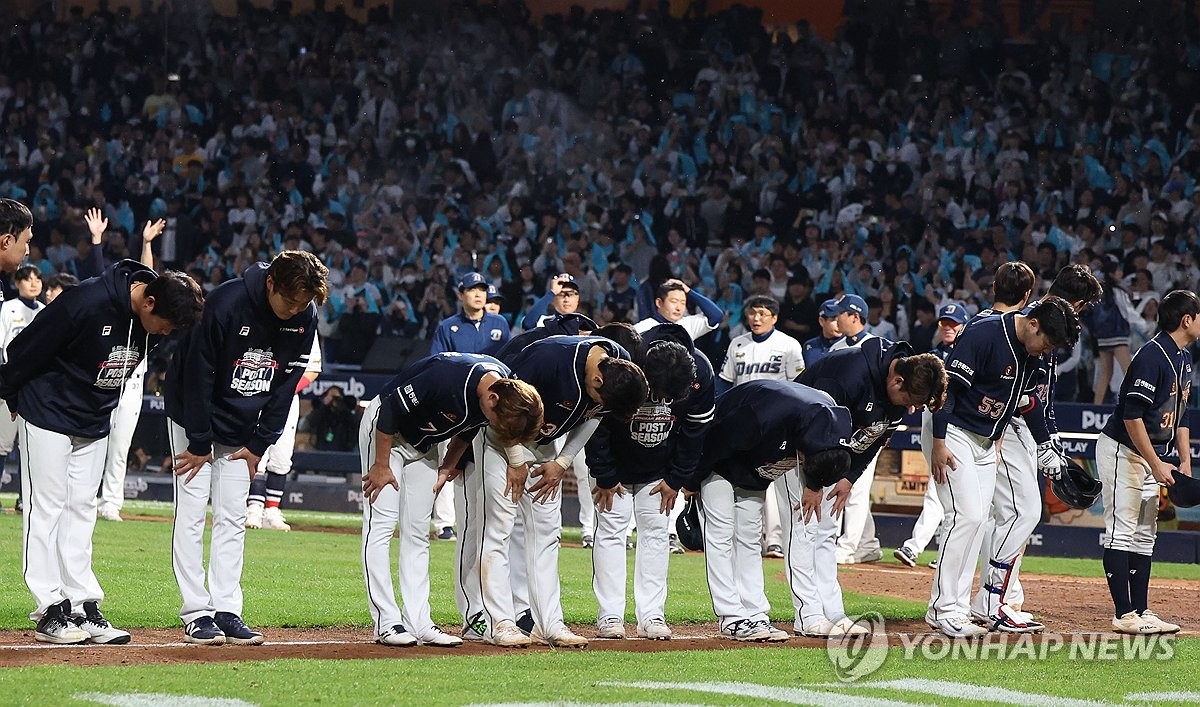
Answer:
[{"left": 359, "top": 397, "right": 438, "bottom": 636}]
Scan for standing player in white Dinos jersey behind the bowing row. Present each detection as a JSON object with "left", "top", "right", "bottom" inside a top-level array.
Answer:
[{"left": 716, "top": 295, "right": 804, "bottom": 558}]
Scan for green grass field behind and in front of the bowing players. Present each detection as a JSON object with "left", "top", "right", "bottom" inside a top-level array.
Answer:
[{"left": 0, "top": 498, "right": 1200, "bottom": 707}]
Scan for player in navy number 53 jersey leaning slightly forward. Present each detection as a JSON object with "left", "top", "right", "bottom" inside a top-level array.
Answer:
[{"left": 925, "top": 296, "right": 1079, "bottom": 637}]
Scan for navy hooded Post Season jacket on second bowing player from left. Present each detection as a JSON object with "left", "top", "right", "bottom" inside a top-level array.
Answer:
[{"left": 166, "top": 263, "right": 317, "bottom": 455}]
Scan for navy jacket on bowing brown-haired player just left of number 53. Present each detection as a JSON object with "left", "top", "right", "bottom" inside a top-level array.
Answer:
[{"left": 796, "top": 336, "right": 912, "bottom": 481}]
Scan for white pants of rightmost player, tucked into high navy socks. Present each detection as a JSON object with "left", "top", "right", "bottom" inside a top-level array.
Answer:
[{"left": 1096, "top": 433, "right": 1158, "bottom": 555}]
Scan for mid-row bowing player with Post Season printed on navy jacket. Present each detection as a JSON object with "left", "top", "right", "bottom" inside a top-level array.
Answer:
[{"left": 587, "top": 324, "right": 713, "bottom": 640}]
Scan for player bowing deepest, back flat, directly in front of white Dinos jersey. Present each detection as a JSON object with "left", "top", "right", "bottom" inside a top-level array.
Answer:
[{"left": 691, "top": 381, "right": 851, "bottom": 641}]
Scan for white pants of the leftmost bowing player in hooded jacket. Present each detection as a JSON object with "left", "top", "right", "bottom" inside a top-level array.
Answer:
[{"left": 17, "top": 418, "right": 108, "bottom": 621}]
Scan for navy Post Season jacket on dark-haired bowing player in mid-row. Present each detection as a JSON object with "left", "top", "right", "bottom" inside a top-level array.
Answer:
[{"left": 587, "top": 326, "right": 715, "bottom": 491}]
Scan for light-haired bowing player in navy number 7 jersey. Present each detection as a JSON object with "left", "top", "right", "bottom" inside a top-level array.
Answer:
[{"left": 359, "top": 352, "right": 542, "bottom": 647}]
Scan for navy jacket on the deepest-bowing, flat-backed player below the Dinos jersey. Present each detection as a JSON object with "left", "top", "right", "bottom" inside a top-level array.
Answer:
[{"left": 684, "top": 381, "right": 853, "bottom": 491}]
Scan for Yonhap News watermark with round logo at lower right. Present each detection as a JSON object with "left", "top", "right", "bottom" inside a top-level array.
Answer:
[{"left": 826, "top": 613, "right": 1176, "bottom": 682}]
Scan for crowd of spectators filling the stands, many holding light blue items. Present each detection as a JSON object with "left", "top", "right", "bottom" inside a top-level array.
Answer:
[{"left": 0, "top": 0, "right": 1200, "bottom": 401}]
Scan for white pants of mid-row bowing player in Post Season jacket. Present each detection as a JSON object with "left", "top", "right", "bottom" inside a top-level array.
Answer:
[{"left": 592, "top": 480, "right": 671, "bottom": 625}]
